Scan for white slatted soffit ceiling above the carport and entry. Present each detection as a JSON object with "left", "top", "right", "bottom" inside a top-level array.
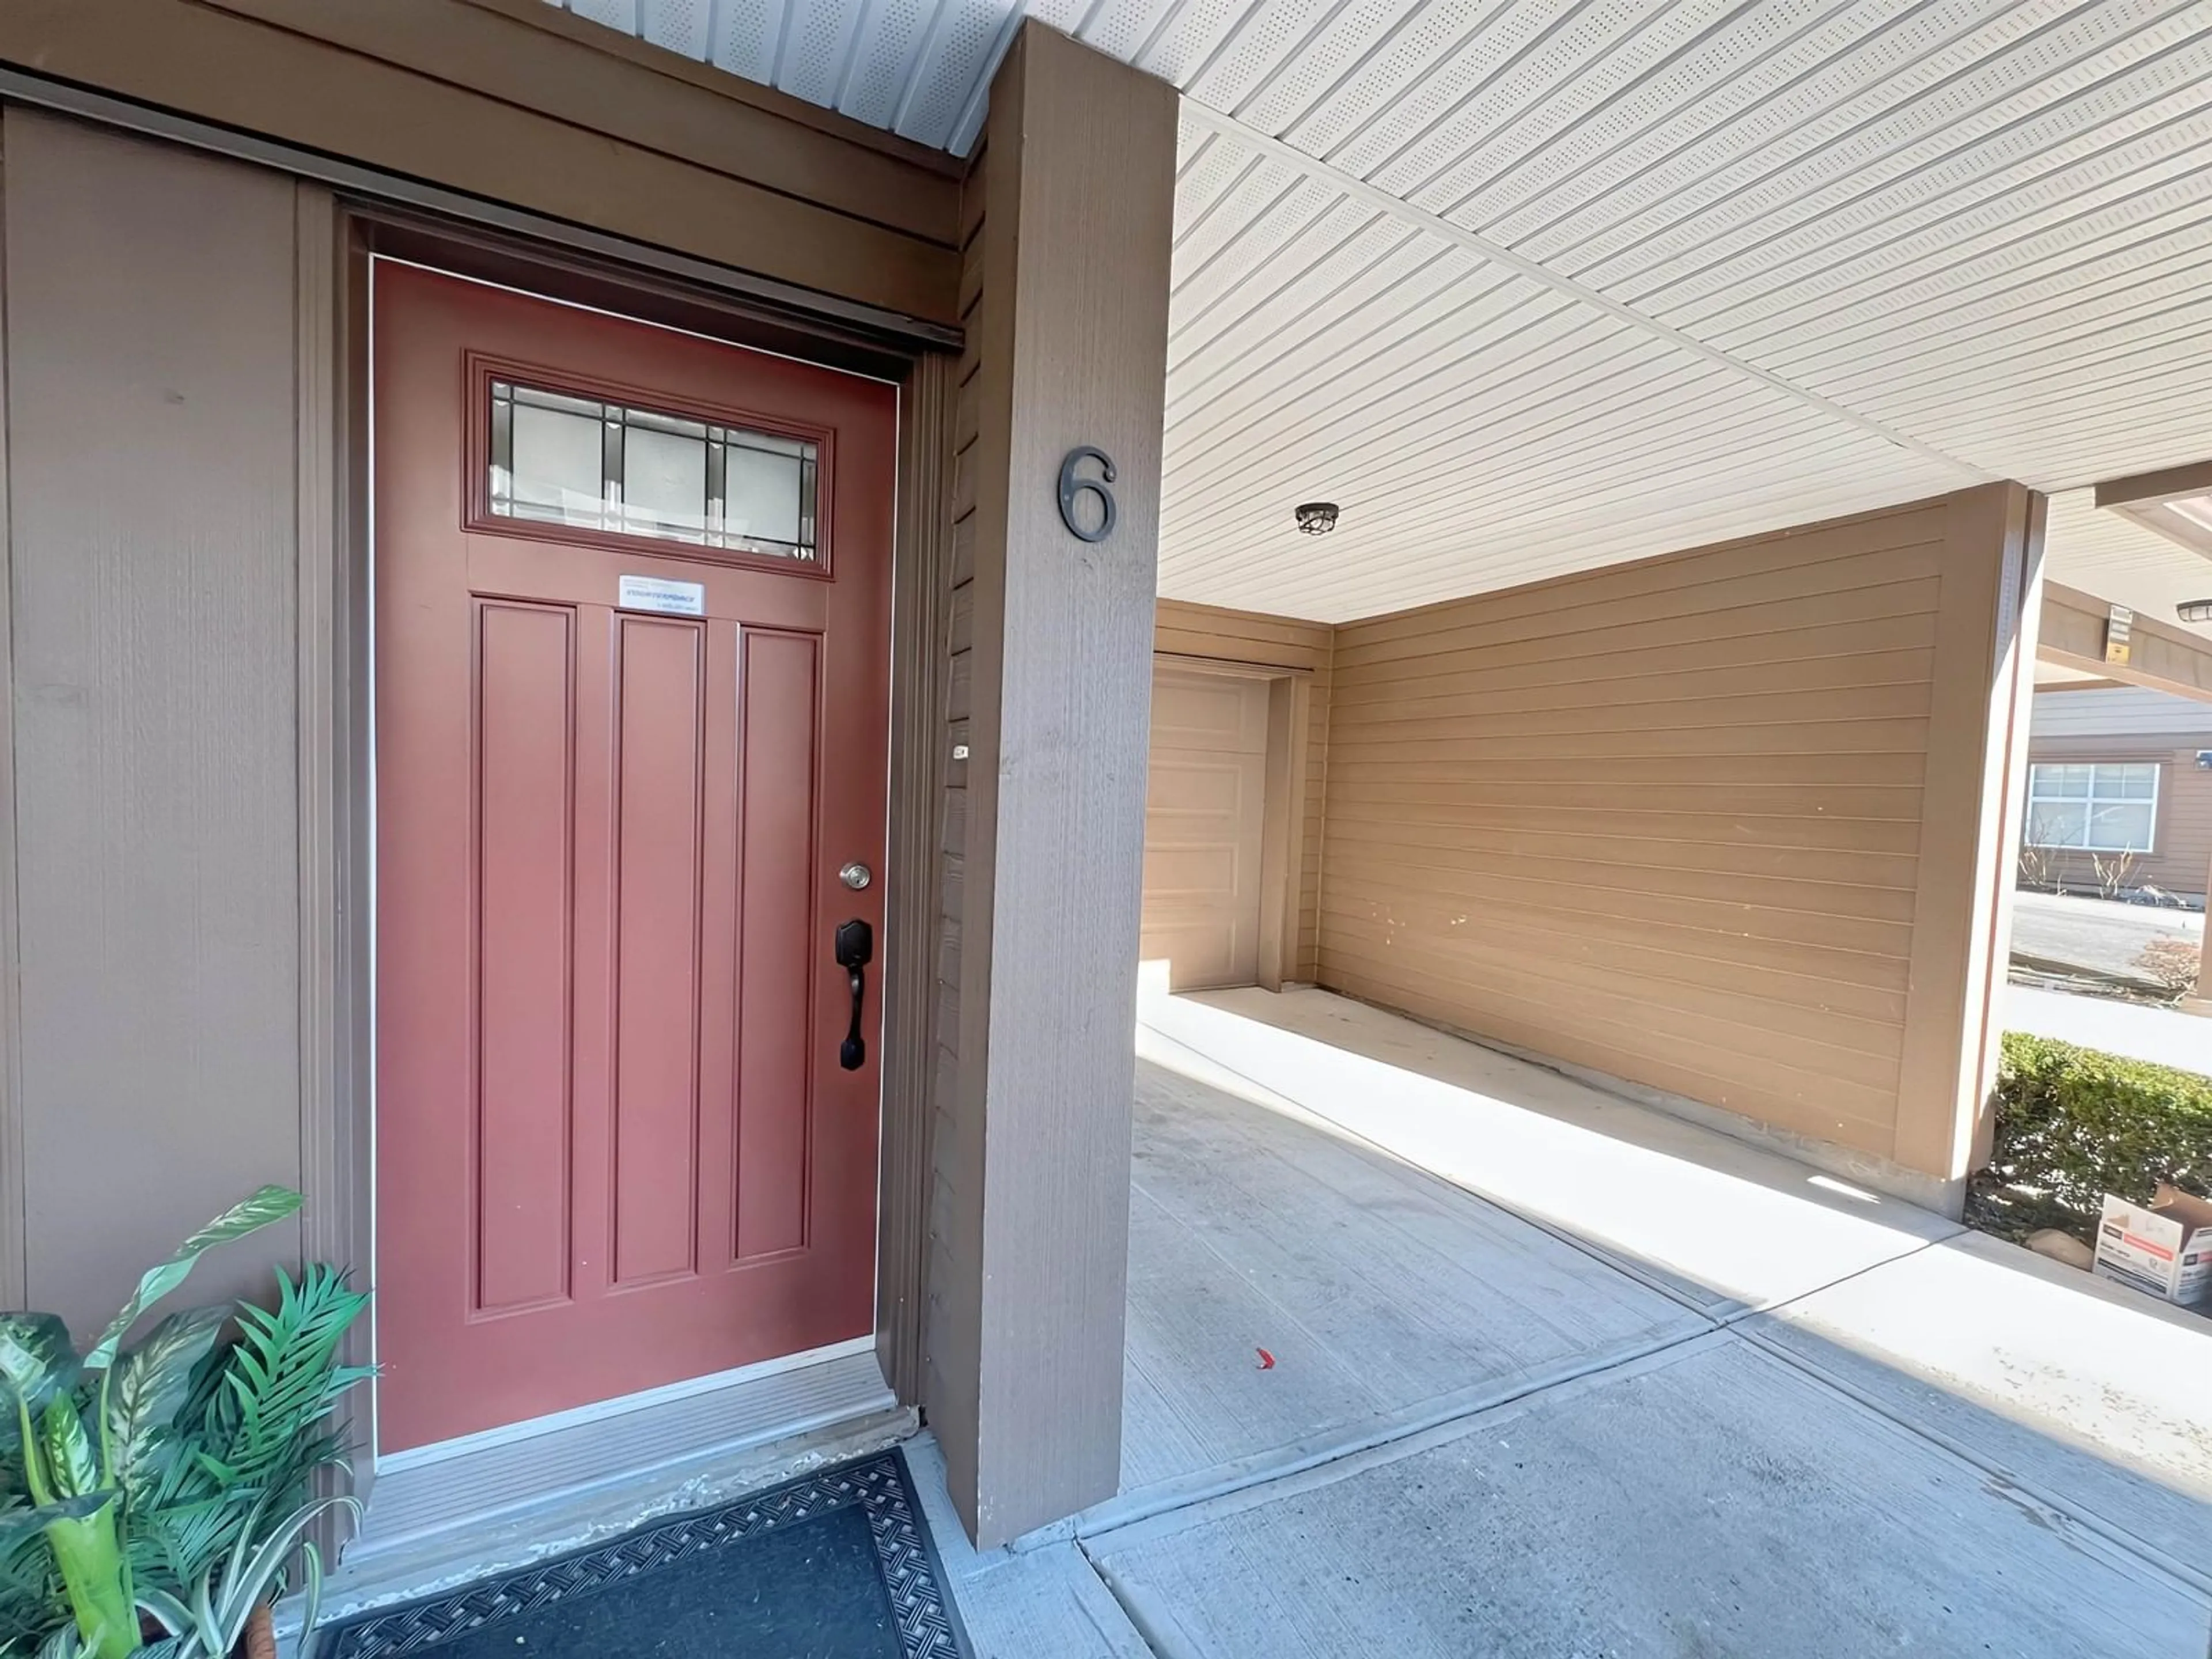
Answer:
[{"left": 555, "top": 0, "right": 2212, "bottom": 622}]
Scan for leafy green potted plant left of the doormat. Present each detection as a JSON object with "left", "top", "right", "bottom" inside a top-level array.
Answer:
[{"left": 0, "top": 1185, "right": 369, "bottom": 1659}]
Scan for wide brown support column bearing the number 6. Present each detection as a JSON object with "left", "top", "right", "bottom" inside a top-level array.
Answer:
[{"left": 925, "top": 22, "right": 1177, "bottom": 1546}]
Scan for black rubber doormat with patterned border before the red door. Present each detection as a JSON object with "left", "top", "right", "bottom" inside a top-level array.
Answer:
[{"left": 316, "top": 1449, "right": 969, "bottom": 1659}]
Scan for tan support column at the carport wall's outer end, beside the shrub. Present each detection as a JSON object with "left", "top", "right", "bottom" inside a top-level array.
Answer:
[{"left": 1893, "top": 484, "right": 2044, "bottom": 1214}]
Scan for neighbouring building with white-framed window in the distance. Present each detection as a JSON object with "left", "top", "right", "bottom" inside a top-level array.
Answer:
[{"left": 2020, "top": 685, "right": 2212, "bottom": 905}]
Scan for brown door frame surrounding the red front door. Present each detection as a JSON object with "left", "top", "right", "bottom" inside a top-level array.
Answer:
[{"left": 298, "top": 198, "right": 951, "bottom": 1498}]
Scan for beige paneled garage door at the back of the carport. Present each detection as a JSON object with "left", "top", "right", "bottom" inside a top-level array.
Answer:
[{"left": 1143, "top": 668, "right": 1267, "bottom": 991}]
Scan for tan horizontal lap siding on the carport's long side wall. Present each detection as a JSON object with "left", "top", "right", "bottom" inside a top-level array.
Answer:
[{"left": 1320, "top": 502, "right": 1944, "bottom": 1153}]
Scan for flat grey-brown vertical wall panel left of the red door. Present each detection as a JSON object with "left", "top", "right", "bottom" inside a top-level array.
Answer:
[{"left": 5, "top": 108, "right": 301, "bottom": 1323}]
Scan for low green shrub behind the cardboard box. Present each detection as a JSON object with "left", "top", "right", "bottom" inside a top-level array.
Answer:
[{"left": 1971, "top": 1029, "right": 2212, "bottom": 1241}]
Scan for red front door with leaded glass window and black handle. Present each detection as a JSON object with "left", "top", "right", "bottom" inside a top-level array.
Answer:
[{"left": 374, "top": 261, "right": 896, "bottom": 1451}]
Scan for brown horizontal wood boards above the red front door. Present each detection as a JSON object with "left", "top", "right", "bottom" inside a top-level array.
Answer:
[{"left": 0, "top": 0, "right": 960, "bottom": 323}]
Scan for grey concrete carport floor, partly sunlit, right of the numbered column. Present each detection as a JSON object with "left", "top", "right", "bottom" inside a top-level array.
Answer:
[{"left": 918, "top": 991, "right": 2212, "bottom": 1659}]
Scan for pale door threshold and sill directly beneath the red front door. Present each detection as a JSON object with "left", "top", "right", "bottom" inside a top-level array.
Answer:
[{"left": 323, "top": 1340, "right": 893, "bottom": 1619}]
